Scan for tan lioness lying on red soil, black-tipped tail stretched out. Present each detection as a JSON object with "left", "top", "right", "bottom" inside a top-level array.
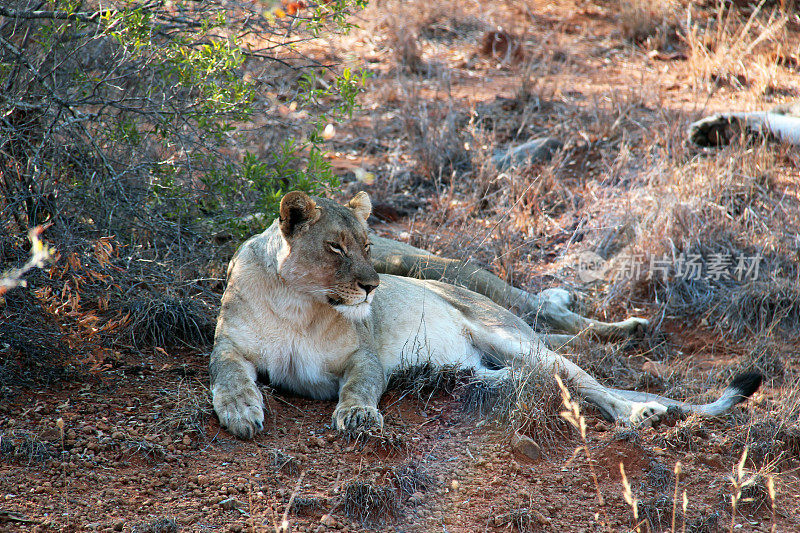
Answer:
[{"left": 210, "top": 192, "right": 761, "bottom": 438}]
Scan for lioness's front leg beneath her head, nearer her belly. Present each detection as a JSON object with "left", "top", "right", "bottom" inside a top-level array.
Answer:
[{"left": 333, "top": 350, "right": 386, "bottom": 432}]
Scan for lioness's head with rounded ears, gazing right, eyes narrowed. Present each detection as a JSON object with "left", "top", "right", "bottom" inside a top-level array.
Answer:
[{"left": 278, "top": 191, "right": 380, "bottom": 320}]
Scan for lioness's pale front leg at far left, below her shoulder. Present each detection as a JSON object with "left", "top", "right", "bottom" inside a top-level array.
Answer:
[{"left": 209, "top": 343, "right": 264, "bottom": 439}]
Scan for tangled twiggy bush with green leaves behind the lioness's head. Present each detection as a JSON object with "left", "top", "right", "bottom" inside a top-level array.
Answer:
[{"left": 0, "top": 0, "right": 364, "bottom": 244}]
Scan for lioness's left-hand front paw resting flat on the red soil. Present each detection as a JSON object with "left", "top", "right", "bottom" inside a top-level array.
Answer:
[{"left": 211, "top": 383, "right": 264, "bottom": 439}]
